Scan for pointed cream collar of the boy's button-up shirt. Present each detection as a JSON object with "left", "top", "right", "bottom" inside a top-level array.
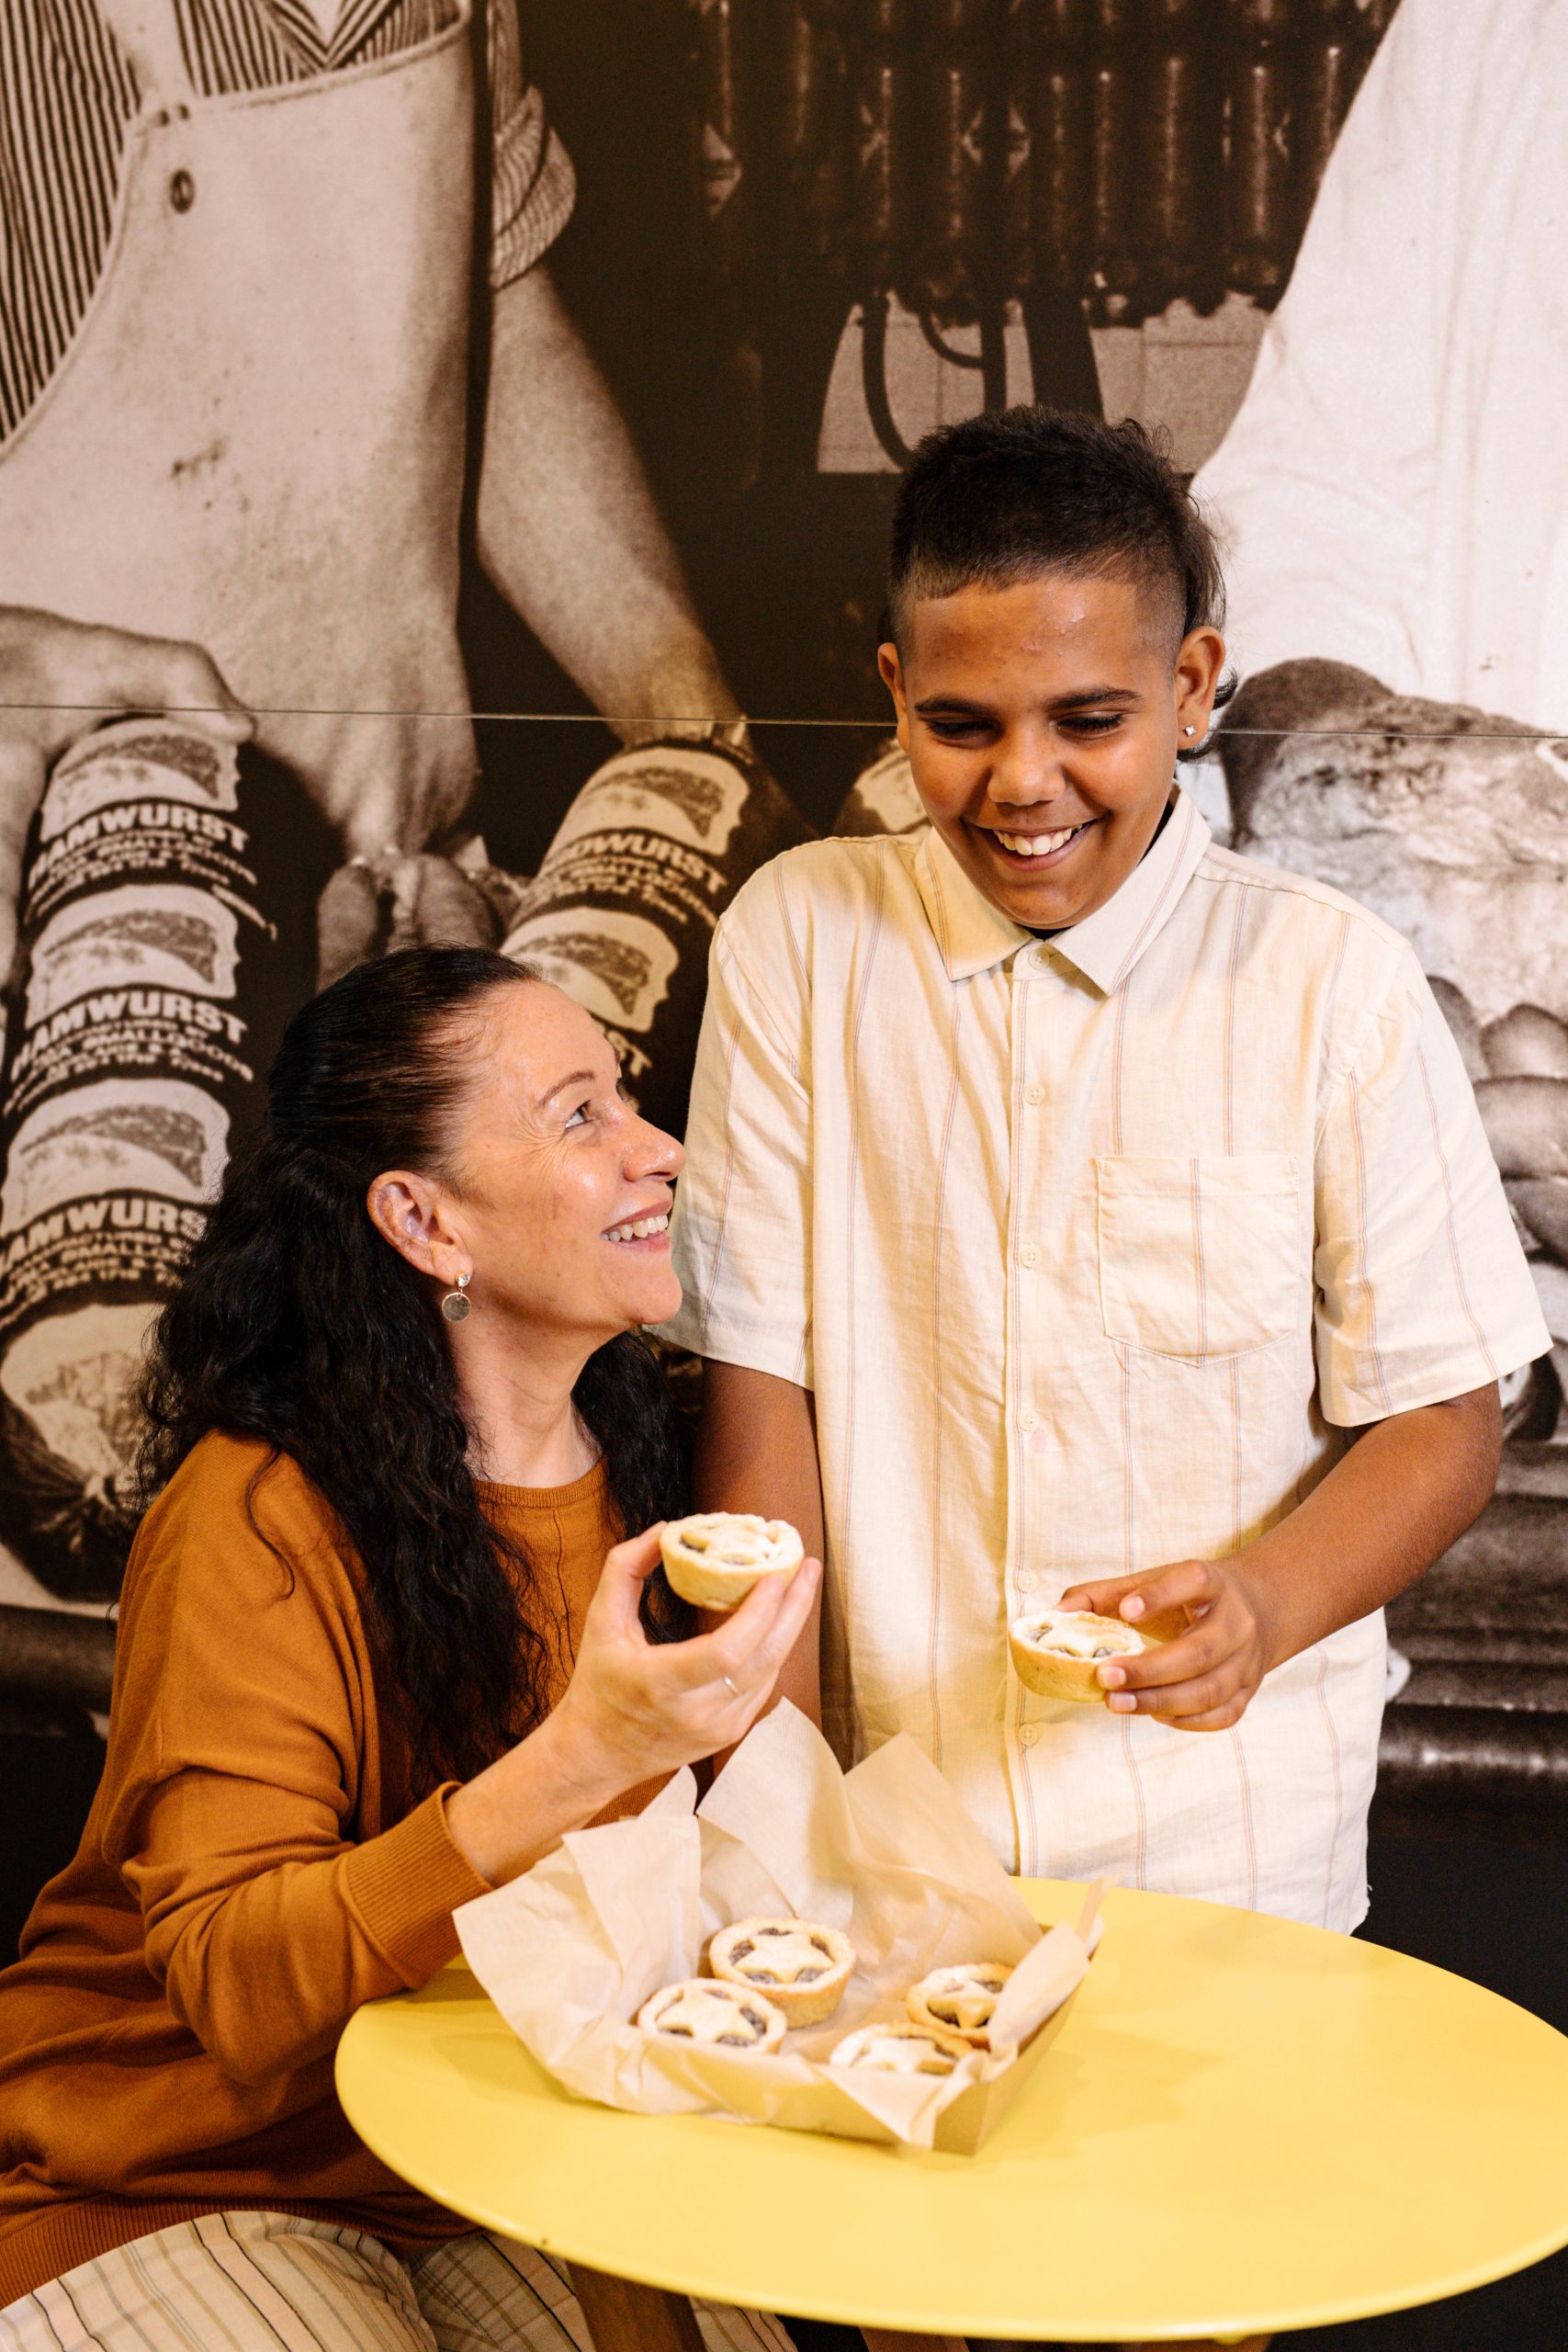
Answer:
[{"left": 915, "top": 786, "right": 1213, "bottom": 995}]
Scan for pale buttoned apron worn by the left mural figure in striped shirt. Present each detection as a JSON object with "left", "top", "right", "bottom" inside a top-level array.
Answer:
[{"left": 0, "top": 0, "right": 475, "bottom": 849}]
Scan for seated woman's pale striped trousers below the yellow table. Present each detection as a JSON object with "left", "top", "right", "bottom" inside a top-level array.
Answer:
[{"left": 0, "top": 2213, "right": 790, "bottom": 2352}]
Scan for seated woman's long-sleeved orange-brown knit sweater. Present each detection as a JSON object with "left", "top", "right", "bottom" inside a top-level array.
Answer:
[{"left": 0, "top": 1437, "right": 649, "bottom": 2307}]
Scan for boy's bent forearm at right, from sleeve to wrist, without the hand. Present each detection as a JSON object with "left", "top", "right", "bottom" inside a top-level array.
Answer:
[{"left": 1232, "top": 1385, "right": 1502, "bottom": 1665}]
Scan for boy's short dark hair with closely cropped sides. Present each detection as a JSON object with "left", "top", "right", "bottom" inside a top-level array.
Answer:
[{"left": 888, "top": 407, "right": 1235, "bottom": 752}]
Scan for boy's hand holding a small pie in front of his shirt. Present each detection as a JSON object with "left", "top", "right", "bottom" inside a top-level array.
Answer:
[{"left": 1058, "top": 1559, "right": 1277, "bottom": 1731}]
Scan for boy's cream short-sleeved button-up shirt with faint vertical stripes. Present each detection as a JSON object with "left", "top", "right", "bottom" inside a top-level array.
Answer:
[{"left": 668, "top": 793, "right": 1550, "bottom": 1928}]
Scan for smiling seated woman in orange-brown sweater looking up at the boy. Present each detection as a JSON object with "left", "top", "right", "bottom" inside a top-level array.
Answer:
[{"left": 0, "top": 948, "right": 820, "bottom": 2352}]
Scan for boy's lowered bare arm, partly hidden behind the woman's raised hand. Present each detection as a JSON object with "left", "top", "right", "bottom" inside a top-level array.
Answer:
[{"left": 691, "top": 1360, "right": 823, "bottom": 1724}]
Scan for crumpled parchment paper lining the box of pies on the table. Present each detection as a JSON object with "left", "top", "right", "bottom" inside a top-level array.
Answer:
[{"left": 456, "top": 1705, "right": 1098, "bottom": 2147}]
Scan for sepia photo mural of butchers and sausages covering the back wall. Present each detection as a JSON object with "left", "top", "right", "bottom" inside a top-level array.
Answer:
[{"left": 0, "top": 0, "right": 1568, "bottom": 1945}]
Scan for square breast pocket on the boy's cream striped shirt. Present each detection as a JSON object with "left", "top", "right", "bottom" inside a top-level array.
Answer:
[{"left": 1096, "top": 1152, "right": 1312, "bottom": 1362}]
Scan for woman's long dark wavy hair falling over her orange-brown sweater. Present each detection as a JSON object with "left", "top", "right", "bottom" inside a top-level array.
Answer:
[{"left": 136, "top": 948, "right": 689, "bottom": 1788}]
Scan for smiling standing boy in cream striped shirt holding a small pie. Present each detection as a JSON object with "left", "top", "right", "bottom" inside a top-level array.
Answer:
[{"left": 670, "top": 409, "right": 1550, "bottom": 1928}]
